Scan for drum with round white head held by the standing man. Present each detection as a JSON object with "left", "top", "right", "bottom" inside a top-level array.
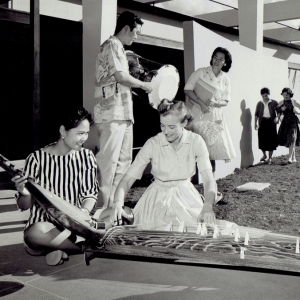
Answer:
[{"left": 126, "top": 50, "right": 179, "bottom": 109}]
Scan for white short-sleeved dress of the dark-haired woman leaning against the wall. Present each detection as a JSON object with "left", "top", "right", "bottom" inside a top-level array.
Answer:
[{"left": 184, "top": 66, "right": 236, "bottom": 161}]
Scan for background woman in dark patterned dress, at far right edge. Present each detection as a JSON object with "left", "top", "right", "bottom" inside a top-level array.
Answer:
[{"left": 277, "top": 88, "right": 300, "bottom": 164}]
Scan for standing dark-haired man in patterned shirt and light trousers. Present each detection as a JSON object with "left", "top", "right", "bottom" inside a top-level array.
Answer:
[{"left": 94, "top": 11, "right": 152, "bottom": 208}]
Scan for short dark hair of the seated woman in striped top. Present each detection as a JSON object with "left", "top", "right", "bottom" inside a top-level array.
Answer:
[{"left": 60, "top": 107, "right": 94, "bottom": 130}]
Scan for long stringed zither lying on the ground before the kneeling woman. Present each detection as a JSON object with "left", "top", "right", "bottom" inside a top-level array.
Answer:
[{"left": 85, "top": 226, "right": 300, "bottom": 272}]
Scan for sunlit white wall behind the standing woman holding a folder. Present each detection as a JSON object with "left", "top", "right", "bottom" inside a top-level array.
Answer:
[{"left": 184, "top": 21, "right": 289, "bottom": 178}]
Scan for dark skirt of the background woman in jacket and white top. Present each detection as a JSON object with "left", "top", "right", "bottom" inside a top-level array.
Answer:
[{"left": 258, "top": 118, "right": 278, "bottom": 151}]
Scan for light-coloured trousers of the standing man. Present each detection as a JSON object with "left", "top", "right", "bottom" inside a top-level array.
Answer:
[{"left": 96, "top": 120, "right": 133, "bottom": 207}]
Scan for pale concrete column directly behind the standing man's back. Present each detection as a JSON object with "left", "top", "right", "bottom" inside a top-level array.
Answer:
[{"left": 82, "top": 0, "right": 117, "bottom": 151}]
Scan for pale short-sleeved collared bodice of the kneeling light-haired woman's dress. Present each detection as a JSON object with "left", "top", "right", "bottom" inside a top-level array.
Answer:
[{"left": 127, "top": 129, "right": 212, "bottom": 182}]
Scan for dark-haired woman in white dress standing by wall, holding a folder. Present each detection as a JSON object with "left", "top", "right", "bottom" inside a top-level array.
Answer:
[{"left": 184, "top": 47, "right": 236, "bottom": 200}]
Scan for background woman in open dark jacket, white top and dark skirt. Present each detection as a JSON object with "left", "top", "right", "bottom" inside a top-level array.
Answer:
[{"left": 254, "top": 87, "right": 278, "bottom": 165}]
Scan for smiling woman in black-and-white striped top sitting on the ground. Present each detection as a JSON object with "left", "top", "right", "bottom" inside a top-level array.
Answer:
[{"left": 12, "top": 108, "right": 99, "bottom": 265}]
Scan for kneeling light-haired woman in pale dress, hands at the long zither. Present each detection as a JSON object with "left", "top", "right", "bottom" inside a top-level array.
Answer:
[{"left": 110, "top": 100, "right": 216, "bottom": 230}]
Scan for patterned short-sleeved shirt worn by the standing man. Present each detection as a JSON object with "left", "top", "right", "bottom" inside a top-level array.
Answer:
[{"left": 94, "top": 36, "right": 134, "bottom": 123}]
